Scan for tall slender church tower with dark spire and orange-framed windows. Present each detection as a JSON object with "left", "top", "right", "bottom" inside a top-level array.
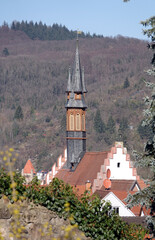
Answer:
[{"left": 65, "top": 38, "right": 87, "bottom": 170}]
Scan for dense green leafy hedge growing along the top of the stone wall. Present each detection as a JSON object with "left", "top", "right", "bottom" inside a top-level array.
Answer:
[{"left": 0, "top": 170, "right": 146, "bottom": 240}]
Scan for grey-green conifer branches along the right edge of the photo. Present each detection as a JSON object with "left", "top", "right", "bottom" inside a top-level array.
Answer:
[{"left": 127, "top": 16, "right": 155, "bottom": 236}]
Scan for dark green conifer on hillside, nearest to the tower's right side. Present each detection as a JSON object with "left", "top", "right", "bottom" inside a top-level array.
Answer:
[{"left": 94, "top": 109, "right": 106, "bottom": 133}]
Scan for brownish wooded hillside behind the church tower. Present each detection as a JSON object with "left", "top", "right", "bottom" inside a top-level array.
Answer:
[{"left": 0, "top": 23, "right": 151, "bottom": 169}]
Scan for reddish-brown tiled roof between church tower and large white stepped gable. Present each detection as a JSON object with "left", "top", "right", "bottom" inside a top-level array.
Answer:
[{"left": 55, "top": 152, "right": 108, "bottom": 186}]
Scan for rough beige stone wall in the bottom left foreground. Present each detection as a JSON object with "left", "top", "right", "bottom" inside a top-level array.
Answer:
[{"left": 0, "top": 198, "right": 88, "bottom": 240}]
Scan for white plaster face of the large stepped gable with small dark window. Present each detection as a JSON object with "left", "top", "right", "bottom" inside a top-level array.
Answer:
[{"left": 107, "top": 148, "right": 136, "bottom": 180}]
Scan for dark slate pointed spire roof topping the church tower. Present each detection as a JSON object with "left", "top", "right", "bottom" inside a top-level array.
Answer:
[{"left": 66, "top": 39, "right": 87, "bottom": 108}]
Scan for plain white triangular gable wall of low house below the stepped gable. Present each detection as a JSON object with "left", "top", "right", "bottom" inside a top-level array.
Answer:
[{"left": 103, "top": 192, "right": 135, "bottom": 217}]
